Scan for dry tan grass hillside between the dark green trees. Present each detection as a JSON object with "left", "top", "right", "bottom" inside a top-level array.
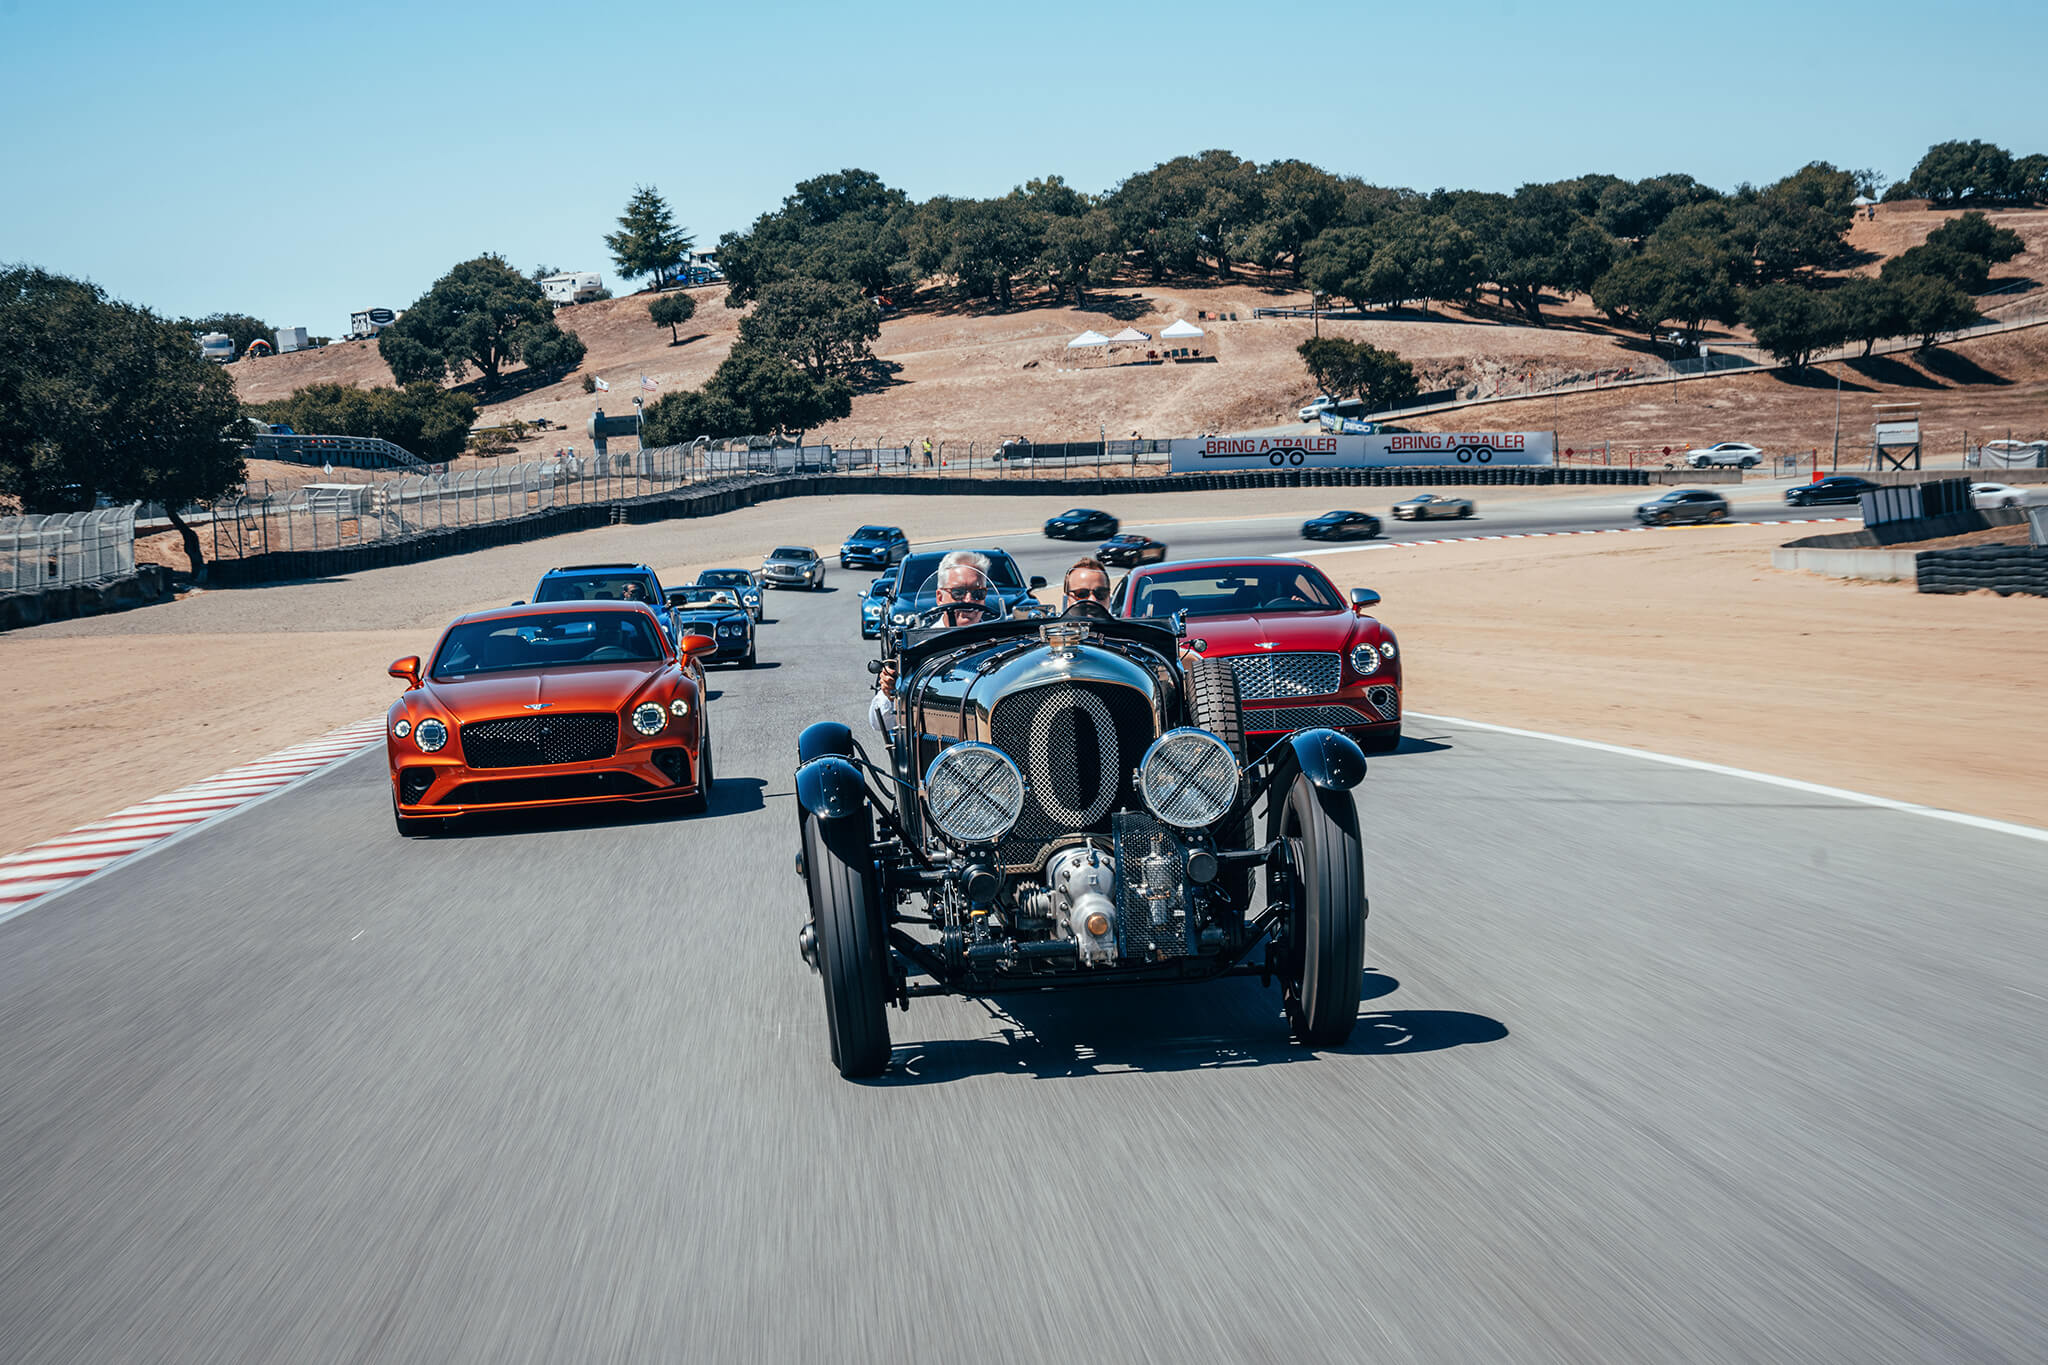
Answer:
[{"left": 229, "top": 201, "right": 2048, "bottom": 448}]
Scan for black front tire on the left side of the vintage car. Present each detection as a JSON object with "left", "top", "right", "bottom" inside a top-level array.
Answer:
[{"left": 803, "top": 808, "right": 889, "bottom": 1081}]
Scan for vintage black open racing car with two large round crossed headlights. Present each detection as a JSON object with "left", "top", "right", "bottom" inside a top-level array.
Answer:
[{"left": 797, "top": 573, "right": 1366, "bottom": 1076}]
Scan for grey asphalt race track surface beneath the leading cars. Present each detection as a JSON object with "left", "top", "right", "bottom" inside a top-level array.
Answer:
[{"left": 0, "top": 519, "right": 2048, "bottom": 1365}]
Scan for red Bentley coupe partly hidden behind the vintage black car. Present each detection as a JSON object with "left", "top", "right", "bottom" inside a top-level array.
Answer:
[{"left": 1110, "top": 559, "right": 1401, "bottom": 753}]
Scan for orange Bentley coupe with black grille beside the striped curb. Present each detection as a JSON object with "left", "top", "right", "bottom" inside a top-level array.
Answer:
[{"left": 385, "top": 602, "right": 715, "bottom": 835}]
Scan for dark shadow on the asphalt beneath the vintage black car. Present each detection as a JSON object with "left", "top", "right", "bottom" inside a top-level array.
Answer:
[{"left": 870, "top": 970, "right": 1507, "bottom": 1085}]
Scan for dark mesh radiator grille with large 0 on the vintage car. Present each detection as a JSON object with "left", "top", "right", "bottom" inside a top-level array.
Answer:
[{"left": 989, "top": 681, "right": 1157, "bottom": 872}]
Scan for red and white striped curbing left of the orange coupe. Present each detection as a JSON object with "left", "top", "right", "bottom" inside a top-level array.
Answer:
[{"left": 0, "top": 718, "right": 383, "bottom": 919}]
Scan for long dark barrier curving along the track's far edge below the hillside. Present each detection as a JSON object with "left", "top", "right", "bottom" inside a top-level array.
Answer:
[{"left": 195, "top": 467, "right": 1651, "bottom": 585}]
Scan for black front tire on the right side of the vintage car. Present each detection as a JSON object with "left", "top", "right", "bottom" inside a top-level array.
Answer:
[{"left": 1280, "top": 774, "right": 1366, "bottom": 1048}]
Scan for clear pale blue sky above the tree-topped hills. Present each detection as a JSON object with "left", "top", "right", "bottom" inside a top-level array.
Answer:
[{"left": 0, "top": 0, "right": 2048, "bottom": 334}]
